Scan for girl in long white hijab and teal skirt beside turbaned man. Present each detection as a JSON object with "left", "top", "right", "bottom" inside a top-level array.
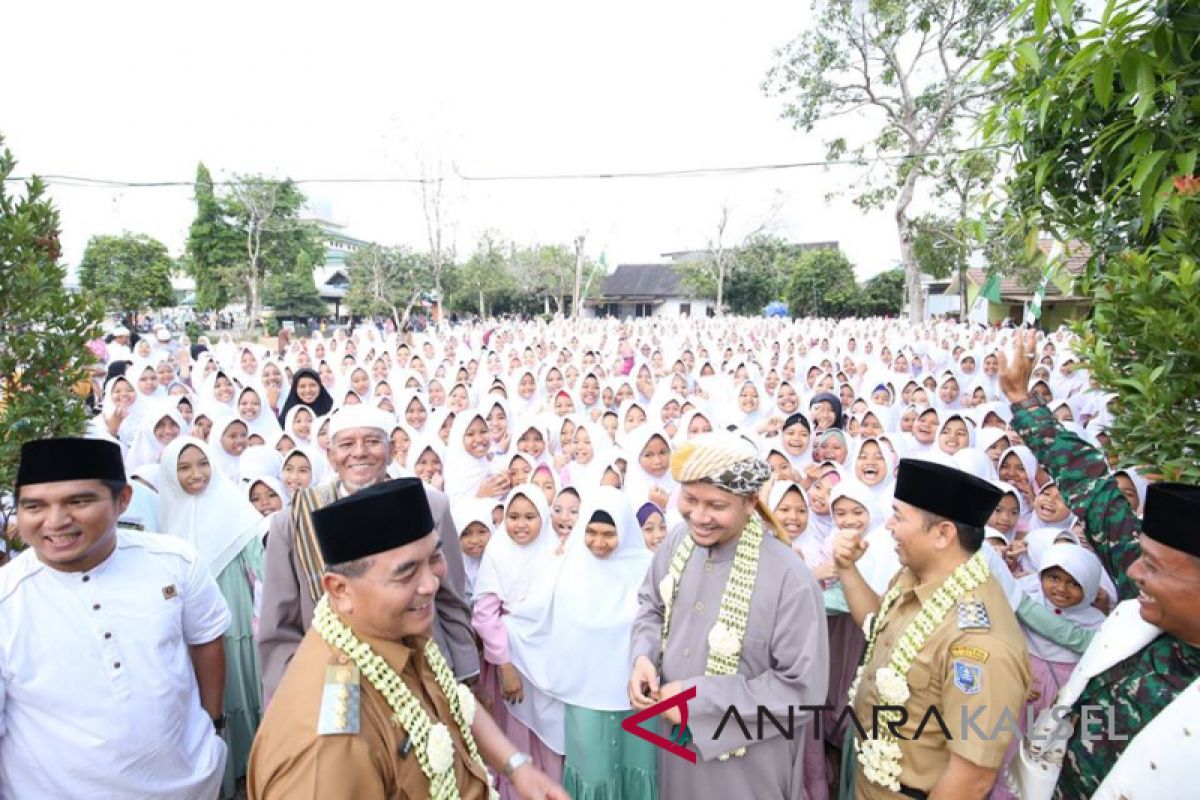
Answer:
[{"left": 530, "top": 486, "right": 658, "bottom": 799}]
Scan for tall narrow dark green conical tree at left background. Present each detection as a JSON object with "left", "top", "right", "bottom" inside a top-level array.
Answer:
[{"left": 186, "top": 162, "right": 245, "bottom": 311}]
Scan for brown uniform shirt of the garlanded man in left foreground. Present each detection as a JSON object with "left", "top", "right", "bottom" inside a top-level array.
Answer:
[{"left": 246, "top": 630, "right": 487, "bottom": 800}]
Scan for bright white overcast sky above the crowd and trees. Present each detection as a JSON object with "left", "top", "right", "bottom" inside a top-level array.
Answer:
[{"left": 0, "top": 0, "right": 899, "bottom": 279}]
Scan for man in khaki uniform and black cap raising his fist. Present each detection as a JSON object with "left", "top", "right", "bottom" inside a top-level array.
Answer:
[{"left": 834, "top": 458, "right": 1030, "bottom": 800}]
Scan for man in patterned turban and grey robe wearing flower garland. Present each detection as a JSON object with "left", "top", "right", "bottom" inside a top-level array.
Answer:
[{"left": 629, "top": 432, "right": 829, "bottom": 800}]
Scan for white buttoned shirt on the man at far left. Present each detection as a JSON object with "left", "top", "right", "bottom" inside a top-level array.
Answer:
[{"left": 0, "top": 529, "right": 229, "bottom": 800}]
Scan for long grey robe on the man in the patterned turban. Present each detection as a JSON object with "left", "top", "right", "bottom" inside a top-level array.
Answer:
[{"left": 631, "top": 524, "right": 829, "bottom": 800}]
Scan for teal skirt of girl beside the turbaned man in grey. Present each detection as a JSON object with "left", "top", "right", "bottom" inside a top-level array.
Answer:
[{"left": 563, "top": 704, "right": 659, "bottom": 800}]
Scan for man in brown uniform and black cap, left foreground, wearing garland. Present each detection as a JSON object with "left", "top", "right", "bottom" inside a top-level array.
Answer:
[{"left": 247, "top": 477, "right": 568, "bottom": 800}]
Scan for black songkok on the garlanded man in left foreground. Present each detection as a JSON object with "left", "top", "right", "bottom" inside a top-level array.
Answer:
[{"left": 312, "top": 477, "right": 433, "bottom": 564}]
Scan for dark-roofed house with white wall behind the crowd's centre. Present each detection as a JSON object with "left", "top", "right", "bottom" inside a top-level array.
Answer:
[{"left": 587, "top": 264, "right": 715, "bottom": 319}]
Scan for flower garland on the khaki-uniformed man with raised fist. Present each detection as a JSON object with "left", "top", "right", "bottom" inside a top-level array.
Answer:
[{"left": 848, "top": 552, "right": 991, "bottom": 792}]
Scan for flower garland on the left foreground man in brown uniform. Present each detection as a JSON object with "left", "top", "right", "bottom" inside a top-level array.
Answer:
[{"left": 312, "top": 595, "right": 499, "bottom": 800}]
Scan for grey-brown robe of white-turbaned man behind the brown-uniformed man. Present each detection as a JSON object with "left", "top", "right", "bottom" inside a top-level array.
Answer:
[{"left": 254, "top": 479, "right": 479, "bottom": 700}]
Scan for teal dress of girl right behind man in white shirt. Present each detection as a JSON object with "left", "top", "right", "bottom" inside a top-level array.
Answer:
[{"left": 217, "top": 535, "right": 263, "bottom": 799}]
